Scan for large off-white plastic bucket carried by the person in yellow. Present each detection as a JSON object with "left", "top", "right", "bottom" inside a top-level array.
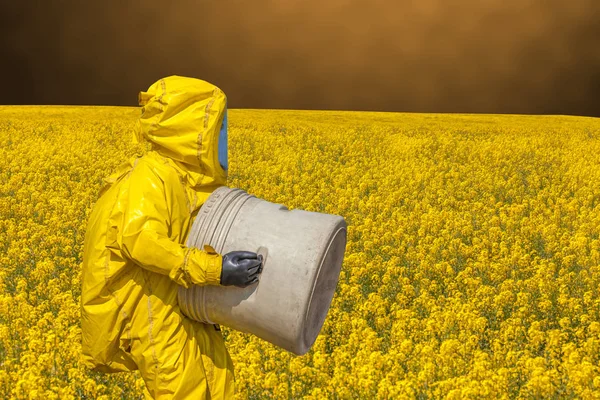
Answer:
[{"left": 178, "top": 186, "right": 347, "bottom": 355}]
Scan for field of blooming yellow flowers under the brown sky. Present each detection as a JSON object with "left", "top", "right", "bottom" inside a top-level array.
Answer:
[{"left": 0, "top": 106, "right": 600, "bottom": 399}]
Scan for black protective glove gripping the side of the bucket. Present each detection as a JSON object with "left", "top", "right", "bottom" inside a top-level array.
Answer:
[{"left": 221, "top": 251, "right": 263, "bottom": 288}]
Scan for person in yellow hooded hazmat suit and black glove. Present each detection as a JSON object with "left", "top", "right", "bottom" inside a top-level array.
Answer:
[{"left": 81, "top": 76, "right": 262, "bottom": 399}]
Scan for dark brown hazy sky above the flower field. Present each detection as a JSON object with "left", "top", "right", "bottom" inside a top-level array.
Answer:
[{"left": 0, "top": 0, "right": 600, "bottom": 117}]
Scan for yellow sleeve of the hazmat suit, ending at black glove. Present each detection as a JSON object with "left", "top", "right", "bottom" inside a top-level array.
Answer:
[{"left": 109, "top": 162, "right": 222, "bottom": 288}]
